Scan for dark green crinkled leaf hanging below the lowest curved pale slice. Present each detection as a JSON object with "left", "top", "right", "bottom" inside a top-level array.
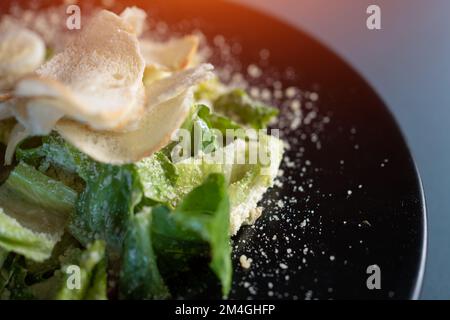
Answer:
[{"left": 69, "top": 164, "right": 141, "bottom": 259}]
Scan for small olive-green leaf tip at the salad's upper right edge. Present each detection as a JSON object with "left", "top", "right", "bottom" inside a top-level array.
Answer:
[{"left": 214, "top": 89, "right": 279, "bottom": 129}]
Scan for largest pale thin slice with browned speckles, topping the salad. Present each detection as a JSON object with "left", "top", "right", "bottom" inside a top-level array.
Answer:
[{"left": 14, "top": 10, "right": 145, "bottom": 134}]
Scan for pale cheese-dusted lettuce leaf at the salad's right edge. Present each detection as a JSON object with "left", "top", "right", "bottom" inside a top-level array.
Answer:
[{"left": 138, "top": 135, "right": 283, "bottom": 238}]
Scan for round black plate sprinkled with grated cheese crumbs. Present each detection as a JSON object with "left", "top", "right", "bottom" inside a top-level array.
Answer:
[{"left": 1, "top": 0, "right": 426, "bottom": 299}]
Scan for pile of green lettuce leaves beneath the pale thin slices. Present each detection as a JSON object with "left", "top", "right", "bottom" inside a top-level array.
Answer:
[{"left": 0, "top": 87, "right": 282, "bottom": 299}]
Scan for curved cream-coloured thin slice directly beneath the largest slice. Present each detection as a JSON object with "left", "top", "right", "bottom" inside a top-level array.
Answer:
[{"left": 56, "top": 90, "right": 194, "bottom": 164}]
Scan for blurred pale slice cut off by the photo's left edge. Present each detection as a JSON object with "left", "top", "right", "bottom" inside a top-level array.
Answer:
[{"left": 0, "top": 20, "right": 45, "bottom": 92}]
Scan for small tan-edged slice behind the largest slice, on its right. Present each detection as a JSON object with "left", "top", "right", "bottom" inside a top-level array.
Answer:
[{"left": 139, "top": 35, "right": 200, "bottom": 71}]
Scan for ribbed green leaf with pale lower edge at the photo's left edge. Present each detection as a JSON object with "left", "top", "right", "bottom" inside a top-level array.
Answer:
[{"left": 0, "top": 163, "right": 77, "bottom": 262}]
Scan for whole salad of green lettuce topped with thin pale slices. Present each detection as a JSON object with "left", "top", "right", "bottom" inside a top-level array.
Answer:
[{"left": 0, "top": 7, "right": 283, "bottom": 300}]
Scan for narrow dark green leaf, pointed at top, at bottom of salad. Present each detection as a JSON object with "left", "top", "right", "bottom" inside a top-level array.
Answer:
[{"left": 119, "top": 208, "right": 170, "bottom": 299}]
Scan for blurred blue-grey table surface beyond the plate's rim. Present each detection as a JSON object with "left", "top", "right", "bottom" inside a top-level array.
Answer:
[{"left": 233, "top": 0, "right": 450, "bottom": 299}]
